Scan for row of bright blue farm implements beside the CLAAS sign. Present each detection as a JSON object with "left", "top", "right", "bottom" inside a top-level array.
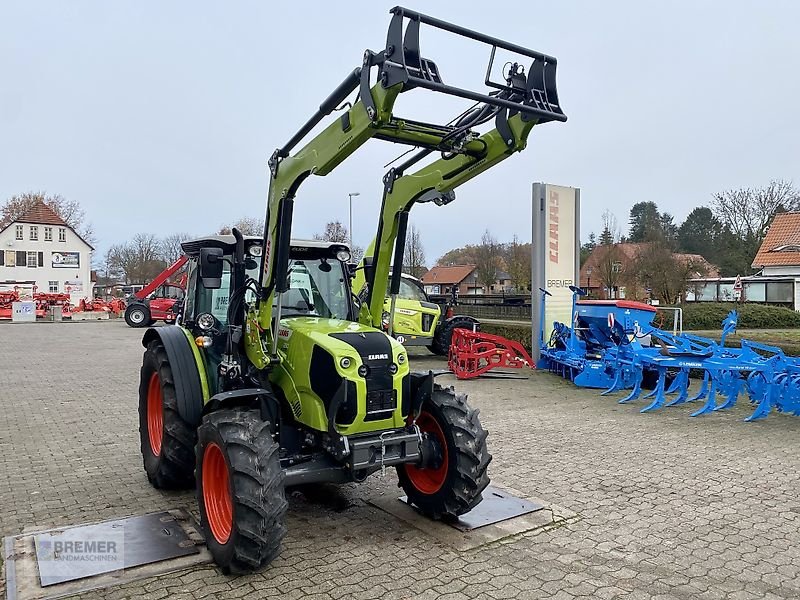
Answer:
[{"left": 536, "top": 287, "right": 800, "bottom": 421}]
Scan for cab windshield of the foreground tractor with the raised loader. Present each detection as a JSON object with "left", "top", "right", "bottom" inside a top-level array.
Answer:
[{"left": 276, "top": 259, "right": 350, "bottom": 319}]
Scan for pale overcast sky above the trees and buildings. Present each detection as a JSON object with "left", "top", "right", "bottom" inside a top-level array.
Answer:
[{"left": 0, "top": 0, "right": 800, "bottom": 263}]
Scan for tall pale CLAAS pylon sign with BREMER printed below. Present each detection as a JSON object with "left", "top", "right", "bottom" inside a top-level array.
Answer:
[{"left": 531, "top": 183, "right": 580, "bottom": 360}]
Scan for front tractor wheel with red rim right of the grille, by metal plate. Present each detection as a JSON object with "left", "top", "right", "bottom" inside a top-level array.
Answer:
[{"left": 397, "top": 385, "right": 492, "bottom": 519}]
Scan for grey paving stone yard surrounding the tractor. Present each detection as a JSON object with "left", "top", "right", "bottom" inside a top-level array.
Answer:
[{"left": 0, "top": 321, "right": 800, "bottom": 600}]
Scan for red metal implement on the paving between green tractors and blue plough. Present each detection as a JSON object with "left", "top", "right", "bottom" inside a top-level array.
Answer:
[{"left": 448, "top": 329, "right": 535, "bottom": 379}]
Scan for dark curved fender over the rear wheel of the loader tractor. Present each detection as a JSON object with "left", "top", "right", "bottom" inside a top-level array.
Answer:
[{"left": 142, "top": 325, "right": 208, "bottom": 427}]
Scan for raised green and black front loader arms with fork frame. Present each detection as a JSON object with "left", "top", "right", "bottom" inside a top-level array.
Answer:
[{"left": 253, "top": 7, "right": 567, "bottom": 368}]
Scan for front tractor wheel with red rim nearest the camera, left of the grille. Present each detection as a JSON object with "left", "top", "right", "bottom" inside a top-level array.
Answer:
[{"left": 195, "top": 410, "right": 288, "bottom": 574}]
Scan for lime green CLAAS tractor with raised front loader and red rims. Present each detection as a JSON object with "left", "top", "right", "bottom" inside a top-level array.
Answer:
[{"left": 139, "top": 7, "right": 566, "bottom": 573}]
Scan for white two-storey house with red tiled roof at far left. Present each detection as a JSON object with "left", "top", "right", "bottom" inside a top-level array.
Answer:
[{"left": 0, "top": 202, "right": 94, "bottom": 304}]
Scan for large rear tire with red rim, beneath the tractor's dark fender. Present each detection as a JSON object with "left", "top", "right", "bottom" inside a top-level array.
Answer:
[{"left": 139, "top": 340, "right": 197, "bottom": 489}]
